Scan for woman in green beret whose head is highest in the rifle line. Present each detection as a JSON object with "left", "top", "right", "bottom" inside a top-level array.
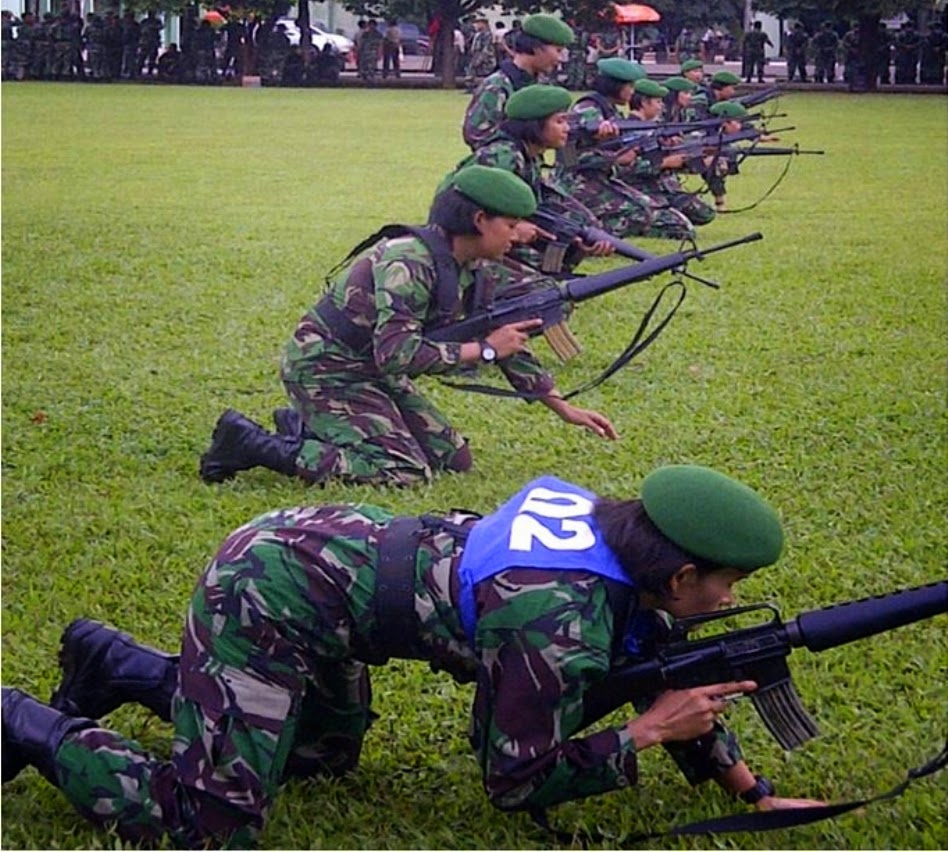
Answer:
[{"left": 461, "top": 15, "right": 573, "bottom": 151}]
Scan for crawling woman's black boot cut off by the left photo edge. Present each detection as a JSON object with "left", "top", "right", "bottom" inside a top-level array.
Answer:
[{"left": 0, "top": 687, "right": 97, "bottom": 784}]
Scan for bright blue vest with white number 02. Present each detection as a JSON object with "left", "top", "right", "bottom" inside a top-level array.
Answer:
[{"left": 458, "top": 476, "right": 635, "bottom": 646}]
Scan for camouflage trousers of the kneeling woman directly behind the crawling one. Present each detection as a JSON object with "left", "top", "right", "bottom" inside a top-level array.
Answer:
[{"left": 283, "top": 373, "right": 470, "bottom": 486}]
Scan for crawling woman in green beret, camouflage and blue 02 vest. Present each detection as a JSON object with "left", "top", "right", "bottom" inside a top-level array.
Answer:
[{"left": 2, "top": 465, "right": 820, "bottom": 848}]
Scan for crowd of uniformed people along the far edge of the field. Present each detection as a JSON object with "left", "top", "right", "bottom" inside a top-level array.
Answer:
[{"left": 2, "top": 5, "right": 948, "bottom": 91}]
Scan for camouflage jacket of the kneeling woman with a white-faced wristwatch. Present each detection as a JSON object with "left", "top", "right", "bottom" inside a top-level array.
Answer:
[{"left": 283, "top": 228, "right": 554, "bottom": 394}]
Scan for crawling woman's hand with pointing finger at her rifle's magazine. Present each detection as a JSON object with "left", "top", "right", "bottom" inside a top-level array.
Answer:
[{"left": 628, "top": 680, "right": 757, "bottom": 749}]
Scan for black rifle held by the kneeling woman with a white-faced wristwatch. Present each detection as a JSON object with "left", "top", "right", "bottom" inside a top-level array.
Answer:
[{"left": 425, "top": 232, "right": 763, "bottom": 352}]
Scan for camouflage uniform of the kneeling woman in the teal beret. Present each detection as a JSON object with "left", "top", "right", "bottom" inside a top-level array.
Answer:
[{"left": 556, "top": 97, "right": 660, "bottom": 237}]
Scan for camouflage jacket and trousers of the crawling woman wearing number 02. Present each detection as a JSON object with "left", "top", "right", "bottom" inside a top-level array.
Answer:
[{"left": 44, "top": 482, "right": 741, "bottom": 847}]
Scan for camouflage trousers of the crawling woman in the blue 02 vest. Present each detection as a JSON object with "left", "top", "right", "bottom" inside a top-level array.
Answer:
[{"left": 49, "top": 506, "right": 388, "bottom": 848}]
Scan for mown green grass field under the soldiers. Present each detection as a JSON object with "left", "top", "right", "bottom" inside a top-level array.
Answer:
[{"left": 0, "top": 83, "right": 948, "bottom": 849}]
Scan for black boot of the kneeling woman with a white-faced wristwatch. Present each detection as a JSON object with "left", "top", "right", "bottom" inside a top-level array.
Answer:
[{"left": 201, "top": 409, "right": 302, "bottom": 482}]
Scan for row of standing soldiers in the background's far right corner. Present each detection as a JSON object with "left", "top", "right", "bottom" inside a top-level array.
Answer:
[{"left": 784, "top": 21, "right": 948, "bottom": 86}]
